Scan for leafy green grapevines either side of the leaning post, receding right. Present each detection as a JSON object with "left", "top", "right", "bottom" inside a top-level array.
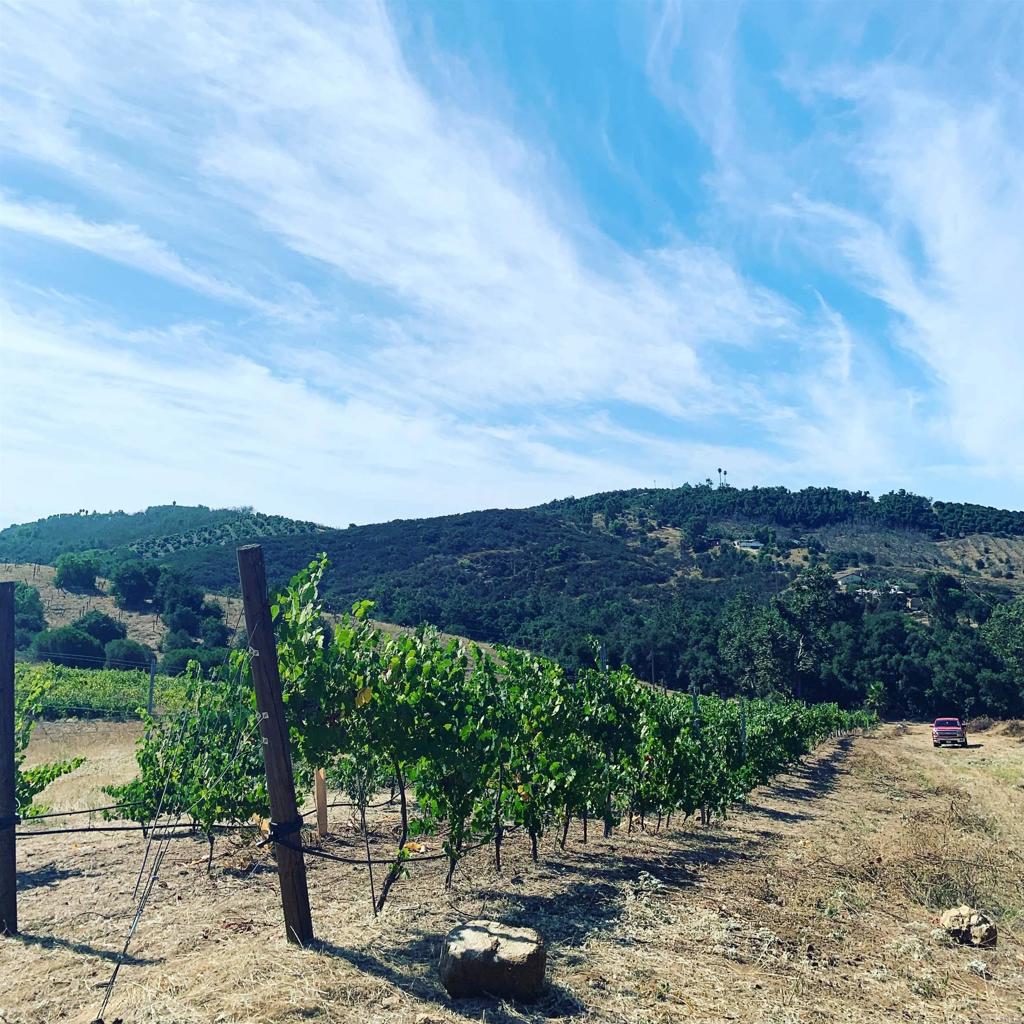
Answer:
[{"left": 99, "top": 556, "right": 874, "bottom": 909}]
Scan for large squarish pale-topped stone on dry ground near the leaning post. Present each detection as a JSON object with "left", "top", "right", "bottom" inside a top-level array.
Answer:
[{"left": 439, "top": 921, "right": 548, "bottom": 1001}]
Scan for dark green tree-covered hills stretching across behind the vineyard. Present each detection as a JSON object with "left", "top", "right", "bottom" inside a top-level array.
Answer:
[{"left": 0, "top": 481, "right": 1024, "bottom": 715}]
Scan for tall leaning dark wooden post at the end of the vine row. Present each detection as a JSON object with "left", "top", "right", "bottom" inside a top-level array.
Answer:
[{"left": 238, "top": 544, "right": 313, "bottom": 946}]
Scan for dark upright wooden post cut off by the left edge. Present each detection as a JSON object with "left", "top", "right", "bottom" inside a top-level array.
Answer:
[{"left": 0, "top": 583, "right": 17, "bottom": 935}]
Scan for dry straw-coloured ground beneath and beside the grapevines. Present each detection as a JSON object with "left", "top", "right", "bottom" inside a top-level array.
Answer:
[{"left": 0, "top": 726, "right": 1024, "bottom": 1024}]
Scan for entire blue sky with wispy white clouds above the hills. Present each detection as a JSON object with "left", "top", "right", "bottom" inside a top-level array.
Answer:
[{"left": 0, "top": 0, "right": 1024, "bottom": 524}]
